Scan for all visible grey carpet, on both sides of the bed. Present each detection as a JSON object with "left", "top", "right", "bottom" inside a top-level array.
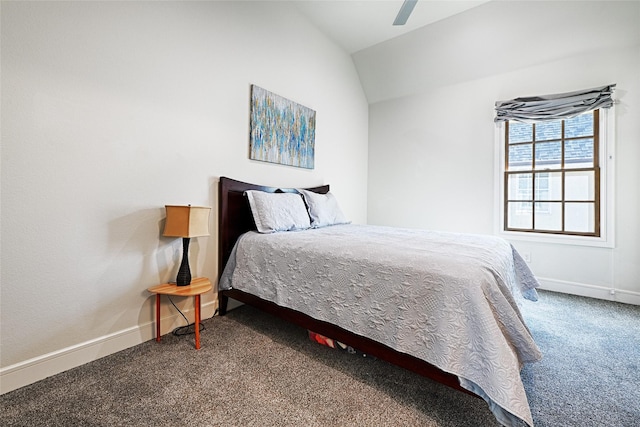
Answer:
[{"left": 0, "top": 292, "right": 640, "bottom": 427}]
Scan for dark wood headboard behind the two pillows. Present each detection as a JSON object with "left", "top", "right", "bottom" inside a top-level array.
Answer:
[{"left": 218, "top": 176, "right": 329, "bottom": 277}]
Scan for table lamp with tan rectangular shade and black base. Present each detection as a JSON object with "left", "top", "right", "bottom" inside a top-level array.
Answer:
[{"left": 163, "top": 205, "right": 211, "bottom": 286}]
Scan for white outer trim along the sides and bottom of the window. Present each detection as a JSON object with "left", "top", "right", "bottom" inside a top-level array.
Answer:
[{"left": 494, "top": 104, "right": 616, "bottom": 248}]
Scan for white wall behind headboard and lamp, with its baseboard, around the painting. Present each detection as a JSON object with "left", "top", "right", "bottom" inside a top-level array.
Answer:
[{"left": 0, "top": 2, "right": 368, "bottom": 392}]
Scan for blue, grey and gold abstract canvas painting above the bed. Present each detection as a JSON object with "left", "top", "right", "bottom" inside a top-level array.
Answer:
[{"left": 249, "top": 85, "right": 316, "bottom": 169}]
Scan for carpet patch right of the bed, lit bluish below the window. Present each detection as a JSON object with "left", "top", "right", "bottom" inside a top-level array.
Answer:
[{"left": 522, "top": 292, "right": 640, "bottom": 427}]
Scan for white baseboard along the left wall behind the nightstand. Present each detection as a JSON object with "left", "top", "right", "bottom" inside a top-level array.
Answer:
[{"left": 0, "top": 302, "right": 216, "bottom": 394}]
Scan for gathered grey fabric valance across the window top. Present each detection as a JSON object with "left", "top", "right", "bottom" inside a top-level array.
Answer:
[{"left": 494, "top": 84, "right": 616, "bottom": 123}]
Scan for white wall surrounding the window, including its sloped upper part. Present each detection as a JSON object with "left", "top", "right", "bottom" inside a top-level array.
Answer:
[{"left": 362, "top": 2, "right": 640, "bottom": 304}]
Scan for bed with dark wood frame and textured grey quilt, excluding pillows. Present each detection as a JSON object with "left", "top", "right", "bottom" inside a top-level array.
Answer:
[{"left": 218, "top": 177, "right": 541, "bottom": 426}]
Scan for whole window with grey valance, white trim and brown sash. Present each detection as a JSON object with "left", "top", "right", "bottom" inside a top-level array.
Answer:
[{"left": 494, "top": 84, "right": 616, "bottom": 248}]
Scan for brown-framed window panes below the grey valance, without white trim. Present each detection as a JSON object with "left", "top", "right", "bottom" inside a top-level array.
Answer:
[{"left": 504, "top": 110, "right": 600, "bottom": 237}]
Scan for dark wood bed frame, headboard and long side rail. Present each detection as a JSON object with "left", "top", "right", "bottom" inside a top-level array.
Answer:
[{"left": 218, "top": 177, "right": 478, "bottom": 397}]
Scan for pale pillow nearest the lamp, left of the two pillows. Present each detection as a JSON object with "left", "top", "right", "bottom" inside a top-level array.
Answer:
[{"left": 245, "top": 190, "right": 311, "bottom": 233}]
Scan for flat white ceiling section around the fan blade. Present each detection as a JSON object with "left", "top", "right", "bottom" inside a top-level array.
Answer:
[{"left": 294, "top": 0, "right": 488, "bottom": 54}]
